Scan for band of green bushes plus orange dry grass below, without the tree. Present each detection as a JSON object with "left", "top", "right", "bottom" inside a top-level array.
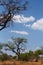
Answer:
[{"left": 0, "top": 50, "right": 43, "bottom": 65}]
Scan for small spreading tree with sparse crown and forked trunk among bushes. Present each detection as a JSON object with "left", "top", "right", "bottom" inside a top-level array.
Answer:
[{"left": 5, "top": 38, "right": 27, "bottom": 59}]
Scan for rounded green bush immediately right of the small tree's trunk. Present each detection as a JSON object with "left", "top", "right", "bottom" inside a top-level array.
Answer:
[{"left": 20, "top": 51, "right": 34, "bottom": 61}]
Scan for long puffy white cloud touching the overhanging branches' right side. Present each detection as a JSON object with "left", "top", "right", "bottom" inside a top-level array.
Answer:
[{"left": 12, "top": 15, "right": 35, "bottom": 23}]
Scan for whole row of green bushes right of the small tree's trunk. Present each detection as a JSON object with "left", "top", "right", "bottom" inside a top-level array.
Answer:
[{"left": 16, "top": 50, "right": 43, "bottom": 61}]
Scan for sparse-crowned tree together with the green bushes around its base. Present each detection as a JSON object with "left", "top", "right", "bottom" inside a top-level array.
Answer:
[{"left": 0, "top": 37, "right": 43, "bottom": 62}]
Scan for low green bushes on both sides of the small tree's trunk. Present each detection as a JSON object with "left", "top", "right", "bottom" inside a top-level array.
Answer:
[{"left": 0, "top": 50, "right": 43, "bottom": 61}]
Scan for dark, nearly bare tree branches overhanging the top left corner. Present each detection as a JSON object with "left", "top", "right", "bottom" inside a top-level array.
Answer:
[{"left": 0, "top": 0, "right": 28, "bottom": 31}]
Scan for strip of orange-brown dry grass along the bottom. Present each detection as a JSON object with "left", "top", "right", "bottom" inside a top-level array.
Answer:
[{"left": 0, "top": 60, "right": 43, "bottom": 65}]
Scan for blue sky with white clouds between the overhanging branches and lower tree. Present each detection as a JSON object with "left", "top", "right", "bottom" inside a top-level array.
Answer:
[{"left": 0, "top": 0, "right": 43, "bottom": 53}]
